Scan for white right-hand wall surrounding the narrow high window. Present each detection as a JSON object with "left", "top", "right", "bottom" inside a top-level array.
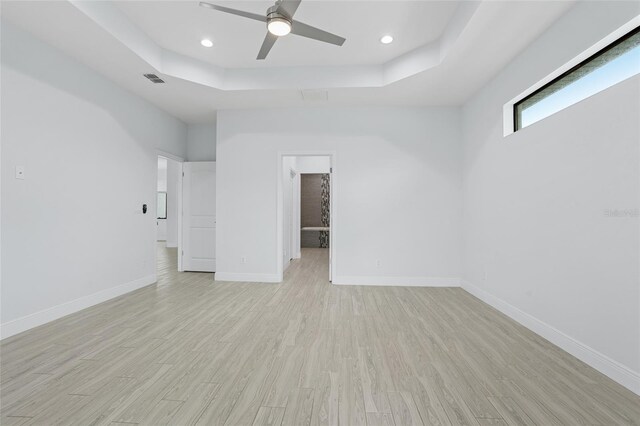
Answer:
[{"left": 463, "top": 2, "right": 640, "bottom": 392}]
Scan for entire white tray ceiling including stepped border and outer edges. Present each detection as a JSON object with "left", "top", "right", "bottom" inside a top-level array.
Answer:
[{"left": 1, "top": 0, "right": 573, "bottom": 122}]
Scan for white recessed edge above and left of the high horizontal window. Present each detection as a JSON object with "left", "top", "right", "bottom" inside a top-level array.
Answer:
[{"left": 502, "top": 15, "right": 640, "bottom": 137}]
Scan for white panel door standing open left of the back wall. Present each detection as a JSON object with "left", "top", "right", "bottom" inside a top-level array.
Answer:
[{"left": 182, "top": 161, "right": 216, "bottom": 272}]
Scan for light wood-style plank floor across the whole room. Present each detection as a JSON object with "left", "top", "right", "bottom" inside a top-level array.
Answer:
[{"left": 0, "top": 248, "right": 640, "bottom": 426}]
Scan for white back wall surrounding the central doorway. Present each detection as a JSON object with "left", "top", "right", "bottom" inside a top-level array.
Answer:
[{"left": 216, "top": 108, "right": 461, "bottom": 285}]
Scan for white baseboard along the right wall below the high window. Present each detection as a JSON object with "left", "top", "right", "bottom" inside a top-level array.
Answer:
[{"left": 462, "top": 280, "right": 640, "bottom": 395}]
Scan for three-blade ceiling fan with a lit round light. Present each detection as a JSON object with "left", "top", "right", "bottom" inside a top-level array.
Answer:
[{"left": 200, "top": 0, "right": 346, "bottom": 59}]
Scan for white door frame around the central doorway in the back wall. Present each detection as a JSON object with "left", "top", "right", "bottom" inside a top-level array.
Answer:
[{"left": 276, "top": 150, "right": 338, "bottom": 281}]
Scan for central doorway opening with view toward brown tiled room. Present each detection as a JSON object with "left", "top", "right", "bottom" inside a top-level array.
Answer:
[{"left": 278, "top": 153, "right": 335, "bottom": 281}]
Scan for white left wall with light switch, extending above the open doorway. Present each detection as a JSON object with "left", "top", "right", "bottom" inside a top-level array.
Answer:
[{"left": 1, "top": 22, "right": 186, "bottom": 337}]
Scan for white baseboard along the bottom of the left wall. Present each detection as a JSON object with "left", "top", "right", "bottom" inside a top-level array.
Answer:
[{"left": 0, "top": 275, "right": 156, "bottom": 339}]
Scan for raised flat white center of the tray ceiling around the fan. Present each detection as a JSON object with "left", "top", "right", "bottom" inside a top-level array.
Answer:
[{"left": 115, "top": 0, "right": 459, "bottom": 68}]
